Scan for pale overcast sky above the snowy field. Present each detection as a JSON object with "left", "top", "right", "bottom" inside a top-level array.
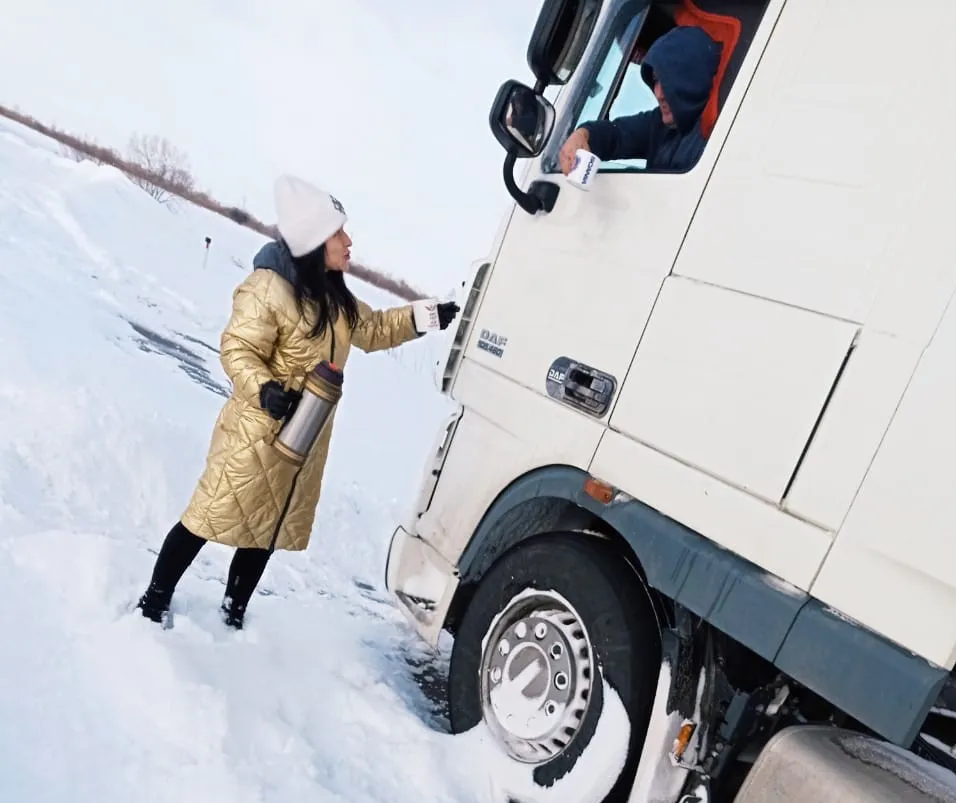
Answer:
[{"left": 0, "top": 0, "right": 540, "bottom": 292}]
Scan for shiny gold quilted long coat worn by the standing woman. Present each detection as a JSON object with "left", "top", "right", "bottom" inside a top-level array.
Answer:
[{"left": 182, "top": 254, "right": 419, "bottom": 550}]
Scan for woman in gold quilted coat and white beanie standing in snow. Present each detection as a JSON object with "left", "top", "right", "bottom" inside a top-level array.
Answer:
[{"left": 137, "top": 176, "right": 458, "bottom": 629}]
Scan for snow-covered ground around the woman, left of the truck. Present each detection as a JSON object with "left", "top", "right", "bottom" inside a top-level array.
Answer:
[{"left": 0, "top": 122, "right": 636, "bottom": 803}]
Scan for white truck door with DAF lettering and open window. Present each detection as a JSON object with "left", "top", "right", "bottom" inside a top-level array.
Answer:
[{"left": 465, "top": 0, "right": 727, "bottom": 417}]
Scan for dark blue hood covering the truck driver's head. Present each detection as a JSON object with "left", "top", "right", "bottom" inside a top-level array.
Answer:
[{"left": 641, "top": 25, "right": 721, "bottom": 134}]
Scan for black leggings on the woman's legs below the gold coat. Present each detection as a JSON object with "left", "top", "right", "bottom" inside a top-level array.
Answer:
[{"left": 151, "top": 522, "right": 272, "bottom": 611}]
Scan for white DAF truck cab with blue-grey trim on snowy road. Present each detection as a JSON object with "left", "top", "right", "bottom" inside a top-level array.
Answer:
[{"left": 386, "top": 0, "right": 956, "bottom": 803}]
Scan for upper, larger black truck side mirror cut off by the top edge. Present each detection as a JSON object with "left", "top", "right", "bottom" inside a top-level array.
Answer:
[{"left": 528, "top": 0, "right": 602, "bottom": 88}]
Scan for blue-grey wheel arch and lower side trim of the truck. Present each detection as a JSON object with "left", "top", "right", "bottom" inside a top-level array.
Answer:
[{"left": 459, "top": 466, "right": 948, "bottom": 746}]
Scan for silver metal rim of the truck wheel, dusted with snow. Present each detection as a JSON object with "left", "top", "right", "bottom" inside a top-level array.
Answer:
[{"left": 480, "top": 589, "right": 593, "bottom": 764}]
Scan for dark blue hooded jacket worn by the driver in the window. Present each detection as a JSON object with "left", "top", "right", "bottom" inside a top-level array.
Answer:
[{"left": 581, "top": 26, "right": 720, "bottom": 172}]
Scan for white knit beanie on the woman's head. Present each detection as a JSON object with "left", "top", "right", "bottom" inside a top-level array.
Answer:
[{"left": 275, "top": 175, "right": 348, "bottom": 257}]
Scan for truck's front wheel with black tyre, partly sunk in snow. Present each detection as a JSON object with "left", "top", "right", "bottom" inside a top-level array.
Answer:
[{"left": 448, "top": 533, "right": 660, "bottom": 803}]
